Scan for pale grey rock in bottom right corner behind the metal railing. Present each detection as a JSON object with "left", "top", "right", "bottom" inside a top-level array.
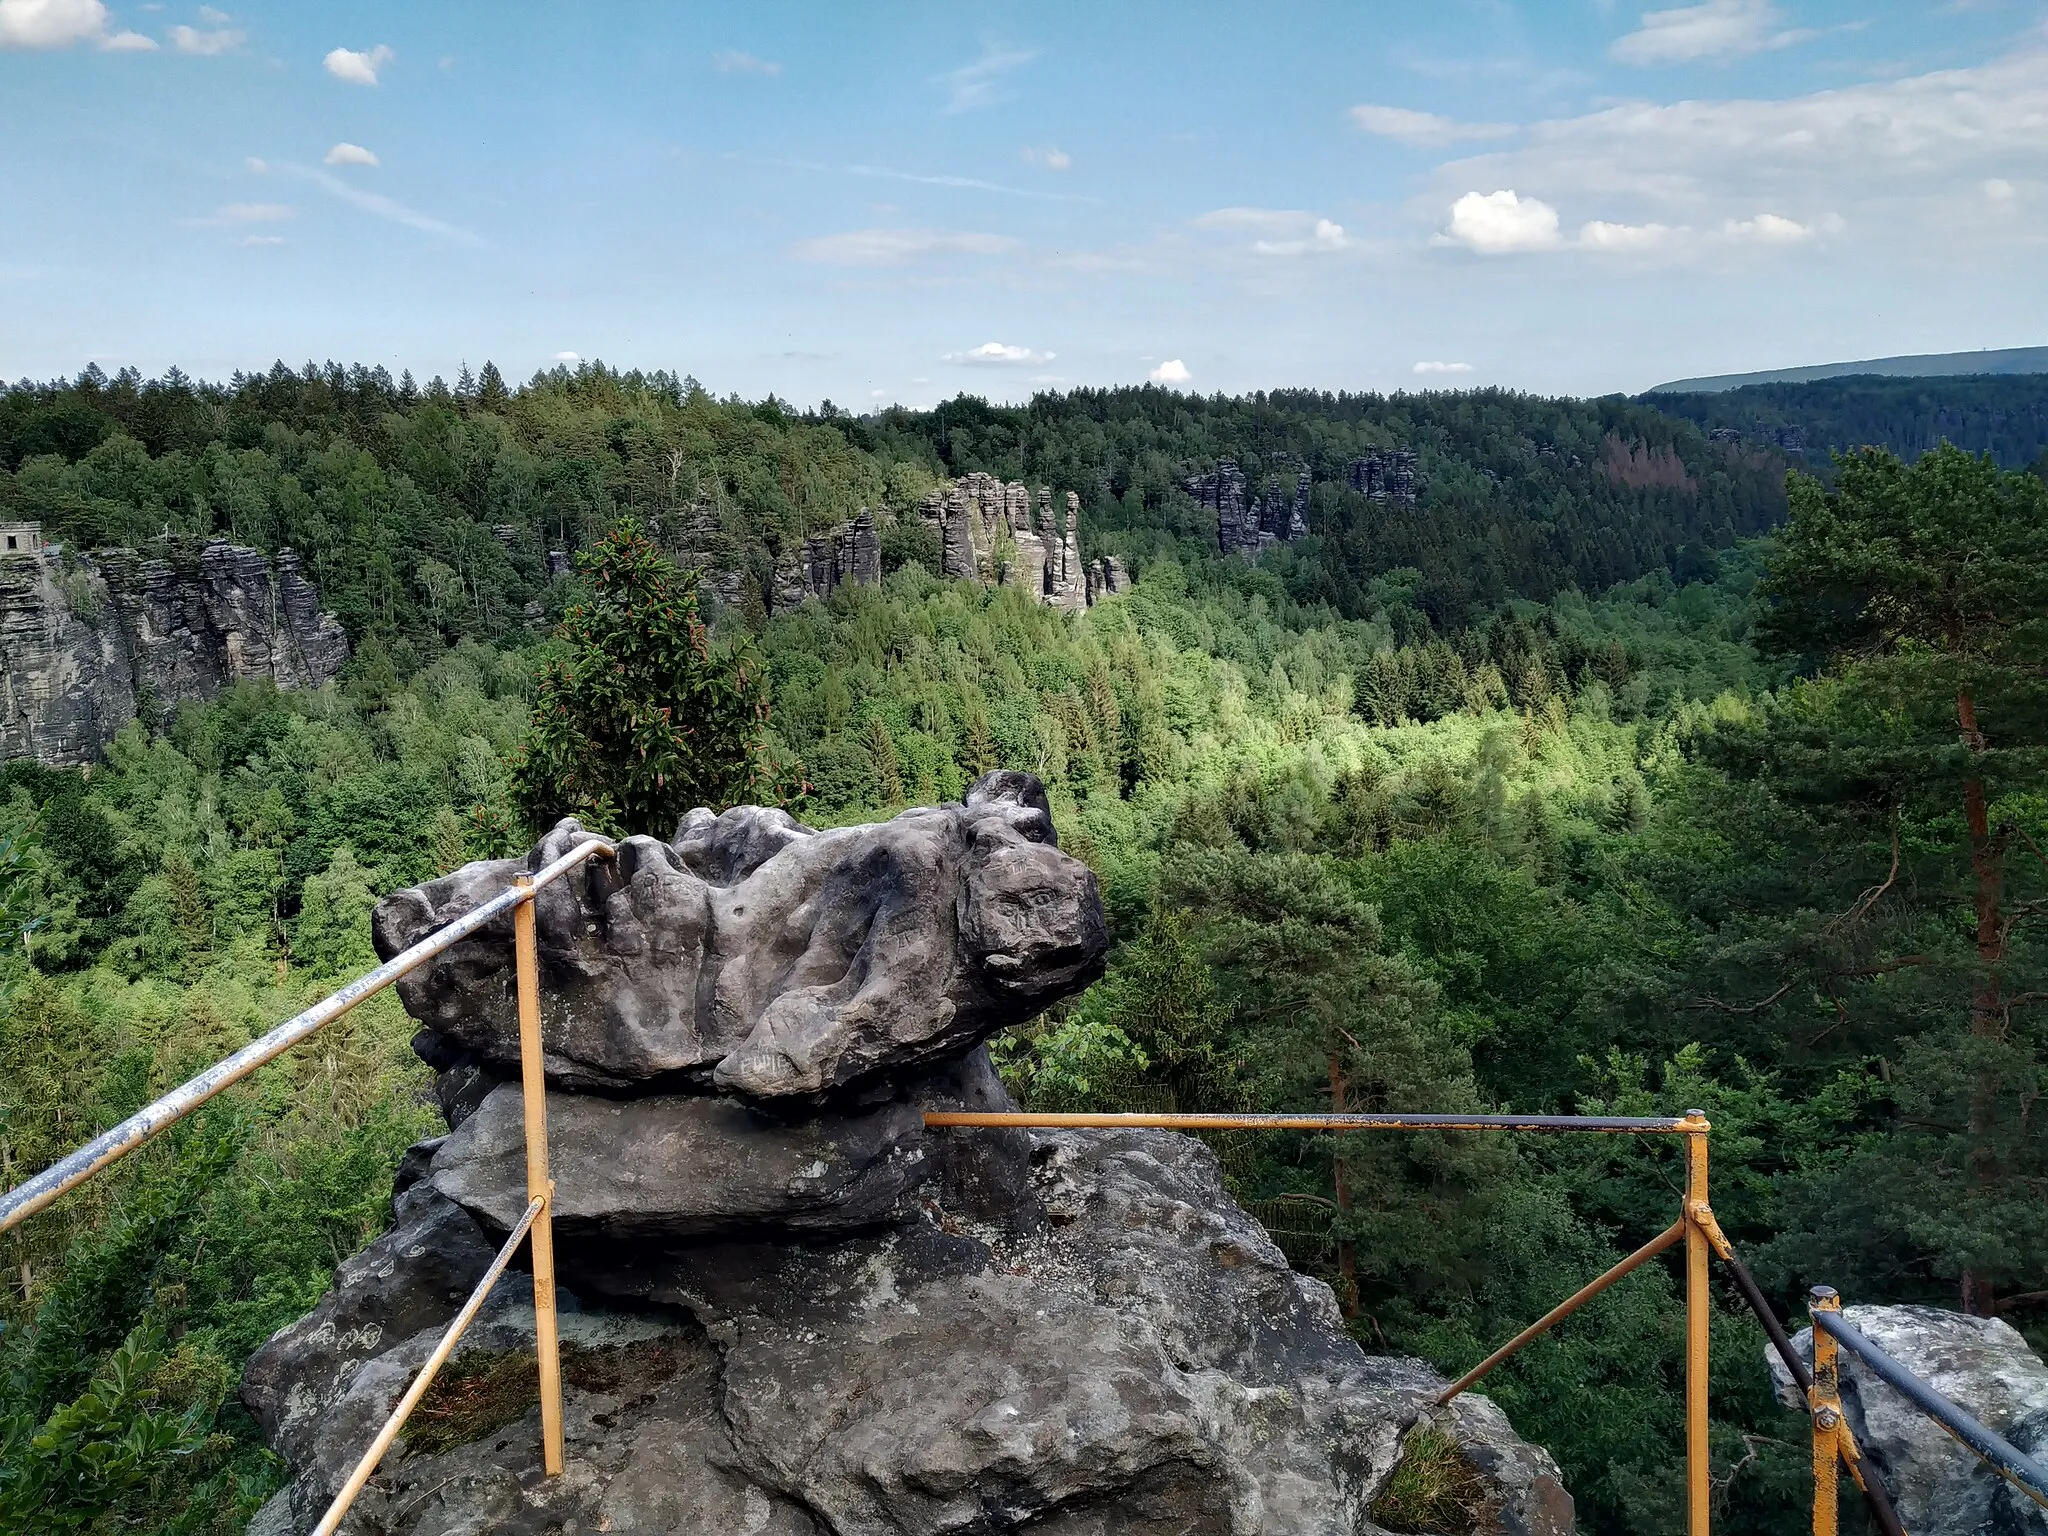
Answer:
[{"left": 1765, "top": 1307, "right": 2048, "bottom": 1536}]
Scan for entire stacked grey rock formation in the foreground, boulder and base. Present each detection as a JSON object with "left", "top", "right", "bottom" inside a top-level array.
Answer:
[{"left": 242, "top": 772, "right": 1571, "bottom": 1536}]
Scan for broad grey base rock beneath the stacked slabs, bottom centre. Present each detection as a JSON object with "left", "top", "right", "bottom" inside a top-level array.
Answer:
[{"left": 258, "top": 1097, "right": 1573, "bottom": 1536}]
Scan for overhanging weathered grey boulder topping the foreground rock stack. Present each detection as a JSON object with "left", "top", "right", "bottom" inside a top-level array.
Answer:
[{"left": 373, "top": 772, "right": 1108, "bottom": 1100}]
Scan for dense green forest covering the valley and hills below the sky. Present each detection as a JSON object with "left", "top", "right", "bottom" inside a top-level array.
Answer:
[{"left": 0, "top": 367, "right": 2048, "bottom": 1536}]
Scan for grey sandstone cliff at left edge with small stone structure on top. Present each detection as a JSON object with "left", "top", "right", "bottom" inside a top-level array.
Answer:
[{"left": 0, "top": 524, "right": 348, "bottom": 768}]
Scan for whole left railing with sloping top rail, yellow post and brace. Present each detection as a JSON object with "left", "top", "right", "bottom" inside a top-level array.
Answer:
[{"left": 0, "top": 838, "right": 614, "bottom": 1536}]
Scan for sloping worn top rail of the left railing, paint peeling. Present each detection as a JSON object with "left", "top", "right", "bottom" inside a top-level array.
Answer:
[{"left": 0, "top": 838, "right": 612, "bottom": 1233}]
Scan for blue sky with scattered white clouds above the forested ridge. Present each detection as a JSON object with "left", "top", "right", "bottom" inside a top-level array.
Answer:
[{"left": 0, "top": 0, "right": 2048, "bottom": 408}]
